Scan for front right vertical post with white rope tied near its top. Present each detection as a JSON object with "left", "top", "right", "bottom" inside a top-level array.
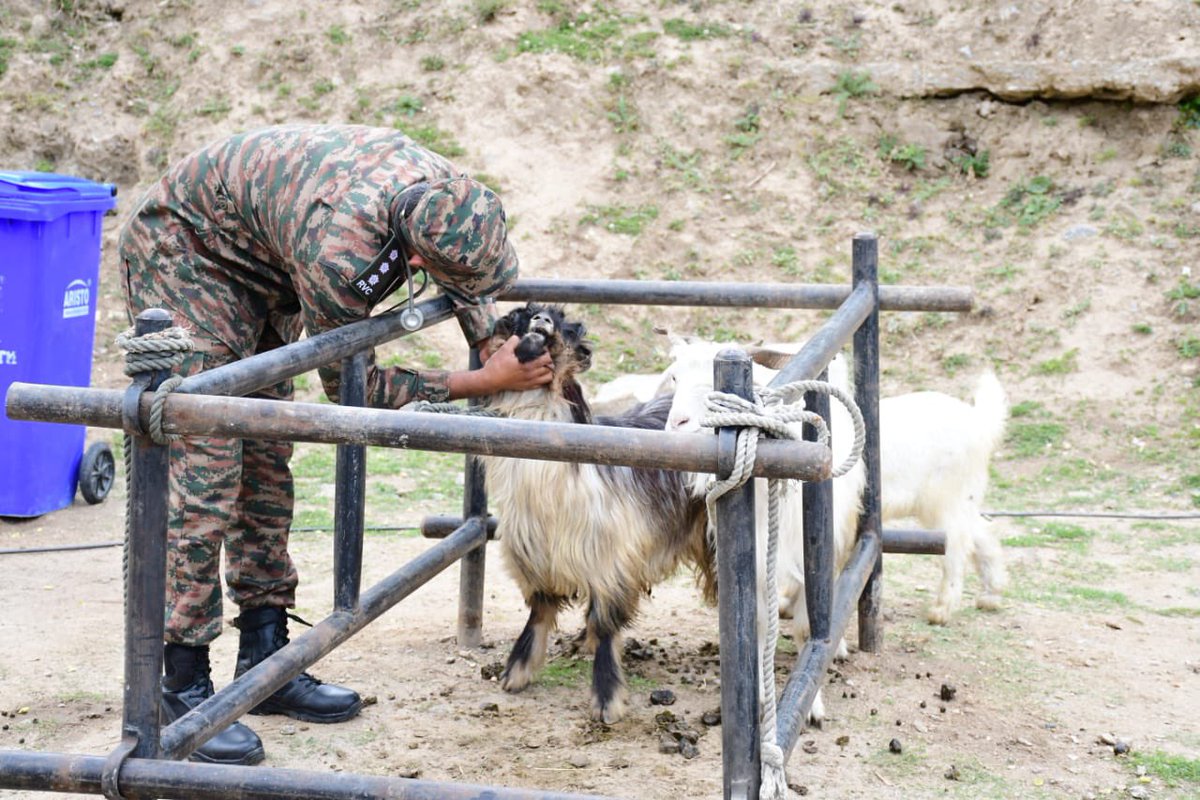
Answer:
[{"left": 713, "top": 349, "right": 762, "bottom": 800}]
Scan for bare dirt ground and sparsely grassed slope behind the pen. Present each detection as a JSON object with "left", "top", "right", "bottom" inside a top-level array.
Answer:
[{"left": 0, "top": 0, "right": 1200, "bottom": 800}]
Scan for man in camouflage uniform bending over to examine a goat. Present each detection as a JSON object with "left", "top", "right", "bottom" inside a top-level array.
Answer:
[{"left": 120, "top": 125, "right": 550, "bottom": 764}]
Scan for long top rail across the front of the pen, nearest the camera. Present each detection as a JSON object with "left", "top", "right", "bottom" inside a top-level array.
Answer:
[{"left": 7, "top": 383, "right": 830, "bottom": 481}]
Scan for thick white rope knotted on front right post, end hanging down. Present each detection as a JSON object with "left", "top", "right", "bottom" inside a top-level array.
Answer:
[{"left": 701, "top": 380, "right": 865, "bottom": 800}]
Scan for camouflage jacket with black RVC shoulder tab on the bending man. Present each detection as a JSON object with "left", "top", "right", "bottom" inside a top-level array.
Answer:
[{"left": 121, "top": 125, "right": 516, "bottom": 408}]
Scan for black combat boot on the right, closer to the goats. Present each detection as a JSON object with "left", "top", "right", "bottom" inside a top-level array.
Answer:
[{"left": 234, "top": 606, "right": 362, "bottom": 722}]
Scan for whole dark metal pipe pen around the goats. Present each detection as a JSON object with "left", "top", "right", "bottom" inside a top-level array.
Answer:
[{"left": 0, "top": 235, "right": 970, "bottom": 798}]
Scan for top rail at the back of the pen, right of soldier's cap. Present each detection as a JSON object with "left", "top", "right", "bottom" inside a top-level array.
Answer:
[{"left": 499, "top": 278, "right": 974, "bottom": 311}]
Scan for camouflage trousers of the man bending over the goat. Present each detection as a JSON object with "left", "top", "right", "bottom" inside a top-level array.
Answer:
[{"left": 127, "top": 268, "right": 299, "bottom": 645}]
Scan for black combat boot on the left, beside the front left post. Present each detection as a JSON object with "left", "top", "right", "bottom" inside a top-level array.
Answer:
[{"left": 160, "top": 643, "right": 265, "bottom": 765}]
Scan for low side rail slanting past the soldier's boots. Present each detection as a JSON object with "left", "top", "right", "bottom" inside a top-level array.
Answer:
[{"left": 161, "top": 519, "right": 486, "bottom": 758}]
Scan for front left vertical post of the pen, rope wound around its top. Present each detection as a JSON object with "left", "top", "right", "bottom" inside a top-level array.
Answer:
[{"left": 121, "top": 308, "right": 170, "bottom": 758}]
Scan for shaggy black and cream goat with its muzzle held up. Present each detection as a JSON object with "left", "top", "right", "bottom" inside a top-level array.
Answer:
[{"left": 484, "top": 303, "right": 713, "bottom": 723}]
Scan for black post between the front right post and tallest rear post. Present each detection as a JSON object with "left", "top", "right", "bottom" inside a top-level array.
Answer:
[{"left": 802, "top": 369, "right": 835, "bottom": 642}]
